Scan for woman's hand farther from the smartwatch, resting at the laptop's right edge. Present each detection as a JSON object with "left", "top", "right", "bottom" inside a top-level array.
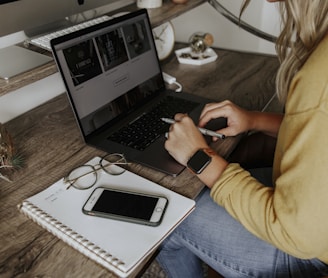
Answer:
[{"left": 199, "top": 100, "right": 252, "bottom": 136}]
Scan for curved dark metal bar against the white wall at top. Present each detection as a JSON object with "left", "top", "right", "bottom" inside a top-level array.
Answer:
[{"left": 207, "top": 0, "right": 277, "bottom": 43}]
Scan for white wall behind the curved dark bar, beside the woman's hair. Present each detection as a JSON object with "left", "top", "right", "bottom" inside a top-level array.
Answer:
[{"left": 172, "top": 0, "right": 280, "bottom": 54}]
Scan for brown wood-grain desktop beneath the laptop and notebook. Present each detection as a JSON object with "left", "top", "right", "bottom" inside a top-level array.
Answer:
[{"left": 0, "top": 45, "right": 278, "bottom": 277}]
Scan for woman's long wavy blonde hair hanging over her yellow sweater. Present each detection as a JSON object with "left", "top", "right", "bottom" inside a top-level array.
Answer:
[{"left": 240, "top": 0, "right": 328, "bottom": 103}]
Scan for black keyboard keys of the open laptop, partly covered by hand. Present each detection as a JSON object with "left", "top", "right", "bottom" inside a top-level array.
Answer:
[{"left": 108, "top": 96, "right": 198, "bottom": 151}]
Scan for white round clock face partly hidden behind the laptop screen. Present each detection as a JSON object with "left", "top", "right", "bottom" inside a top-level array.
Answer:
[{"left": 153, "top": 22, "right": 175, "bottom": 60}]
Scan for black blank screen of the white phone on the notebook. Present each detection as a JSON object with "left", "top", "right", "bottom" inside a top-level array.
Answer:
[{"left": 92, "top": 190, "right": 158, "bottom": 220}]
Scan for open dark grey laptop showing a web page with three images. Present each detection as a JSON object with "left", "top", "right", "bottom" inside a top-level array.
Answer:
[{"left": 51, "top": 9, "right": 225, "bottom": 176}]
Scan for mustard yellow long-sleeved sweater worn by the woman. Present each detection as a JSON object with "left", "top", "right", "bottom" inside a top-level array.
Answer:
[{"left": 211, "top": 37, "right": 328, "bottom": 263}]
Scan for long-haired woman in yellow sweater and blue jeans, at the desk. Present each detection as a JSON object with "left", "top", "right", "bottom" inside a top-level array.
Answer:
[{"left": 158, "top": 0, "right": 328, "bottom": 278}]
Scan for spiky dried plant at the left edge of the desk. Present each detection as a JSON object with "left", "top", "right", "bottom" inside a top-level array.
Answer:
[{"left": 0, "top": 123, "right": 23, "bottom": 181}]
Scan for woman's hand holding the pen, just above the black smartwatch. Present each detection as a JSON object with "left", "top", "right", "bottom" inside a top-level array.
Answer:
[{"left": 165, "top": 114, "right": 208, "bottom": 166}]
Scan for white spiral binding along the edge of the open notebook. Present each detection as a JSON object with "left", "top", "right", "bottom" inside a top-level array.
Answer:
[{"left": 18, "top": 201, "right": 125, "bottom": 271}]
